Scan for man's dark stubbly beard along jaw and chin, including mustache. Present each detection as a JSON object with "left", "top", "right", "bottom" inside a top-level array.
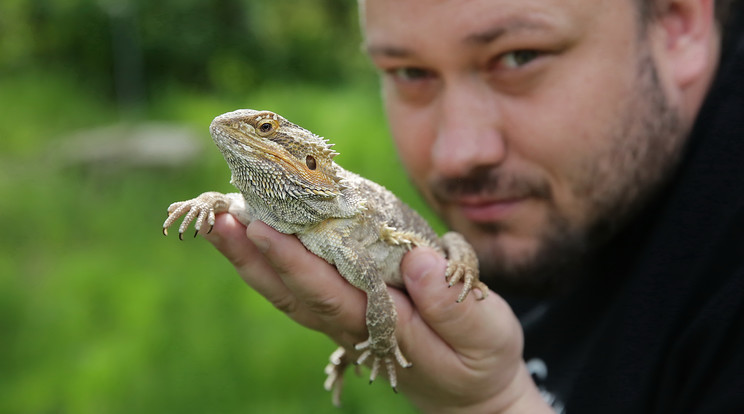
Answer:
[{"left": 430, "top": 50, "right": 685, "bottom": 295}]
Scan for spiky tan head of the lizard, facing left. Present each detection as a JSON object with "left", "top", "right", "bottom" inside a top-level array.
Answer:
[{"left": 209, "top": 109, "right": 341, "bottom": 199}]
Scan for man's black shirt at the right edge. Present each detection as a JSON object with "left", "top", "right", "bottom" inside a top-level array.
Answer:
[{"left": 507, "top": 6, "right": 744, "bottom": 414}]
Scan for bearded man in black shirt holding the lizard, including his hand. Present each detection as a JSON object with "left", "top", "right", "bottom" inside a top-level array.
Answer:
[{"left": 207, "top": 0, "right": 744, "bottom": 413}]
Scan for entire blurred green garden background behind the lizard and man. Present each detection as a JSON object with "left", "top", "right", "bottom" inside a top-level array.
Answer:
[{"left": 0, "top": 0, "right": 438, "bottom": 413}]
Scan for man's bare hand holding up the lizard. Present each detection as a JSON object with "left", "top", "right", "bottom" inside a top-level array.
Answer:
[{"left": 205, "top": 214, "right": 552, "bottom": 413}]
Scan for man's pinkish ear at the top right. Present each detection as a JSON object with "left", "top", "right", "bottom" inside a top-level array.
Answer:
[{"left": 656, "top": 0, "right": 718, "bottom": 89}]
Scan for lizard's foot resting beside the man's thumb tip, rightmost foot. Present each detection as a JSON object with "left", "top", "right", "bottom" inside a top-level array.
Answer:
[{"left": 442, "top": 232, "right": 488, "bottom": 303}]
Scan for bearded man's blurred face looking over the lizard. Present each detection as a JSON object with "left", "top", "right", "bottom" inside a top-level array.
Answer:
[{"left": 360, "top": 0, "right": 685, "bottom": 289}]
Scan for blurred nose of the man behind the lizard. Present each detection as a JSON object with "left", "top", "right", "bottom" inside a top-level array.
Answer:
[{"left": 432, "top": 79, "right": 506, "bottom": 177}]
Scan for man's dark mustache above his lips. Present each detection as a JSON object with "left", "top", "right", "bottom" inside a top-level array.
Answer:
[{"left": 429, "top": 168, "right": 552, "bottom": 202}]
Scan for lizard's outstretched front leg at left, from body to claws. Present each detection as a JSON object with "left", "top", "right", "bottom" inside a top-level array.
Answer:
[{"left": 163, "top": 191, "right": 251, "bottom": 240}]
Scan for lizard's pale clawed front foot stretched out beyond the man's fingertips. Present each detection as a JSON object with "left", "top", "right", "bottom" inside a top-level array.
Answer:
[{"left": 163, "top": 192, "right": 228, "bottom": 240}]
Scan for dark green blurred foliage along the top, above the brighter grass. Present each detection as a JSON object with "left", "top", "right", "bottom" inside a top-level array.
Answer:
[{"left": 0, "top": 0, "right": 363, "bottom": 98}]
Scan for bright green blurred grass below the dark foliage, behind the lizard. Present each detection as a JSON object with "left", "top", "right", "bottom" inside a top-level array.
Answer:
[{"left": 0, "top": 72, "right": 436, "bottom": 414}]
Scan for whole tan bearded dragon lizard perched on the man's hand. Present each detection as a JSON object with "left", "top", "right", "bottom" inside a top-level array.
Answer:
[{"left": 163, "top": 109, "right": 488, "bottom": 404}]
